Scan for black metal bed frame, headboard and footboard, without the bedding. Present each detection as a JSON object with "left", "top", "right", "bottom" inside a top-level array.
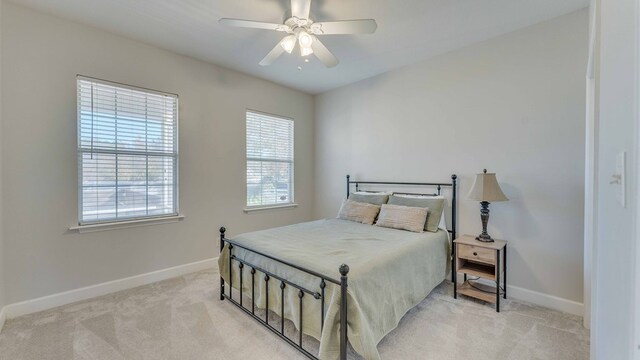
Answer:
[{"left": 220, "top": 174, "right": 458, "bottom": 360}]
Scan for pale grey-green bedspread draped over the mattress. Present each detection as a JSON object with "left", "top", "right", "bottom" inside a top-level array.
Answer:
[{"left": 218, "top": 219, "right": 450, "bottom": 360}]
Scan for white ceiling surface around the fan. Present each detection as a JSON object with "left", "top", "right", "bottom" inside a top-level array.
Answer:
[{"left": 12, "top": 0, "right": 589, "bottom": 94}]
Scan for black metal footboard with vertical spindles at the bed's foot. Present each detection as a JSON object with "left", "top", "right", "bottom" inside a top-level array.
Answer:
[{"left": 220, "top": 227, "right": 349, "bottom": 360}]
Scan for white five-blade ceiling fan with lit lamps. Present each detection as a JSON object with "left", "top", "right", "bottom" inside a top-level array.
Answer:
[{"left": 219, "top": 0, "right": 378, "bottom": 68}]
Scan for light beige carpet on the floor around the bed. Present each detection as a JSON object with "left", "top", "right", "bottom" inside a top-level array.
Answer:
[{"left": 0, "top": 270, "right": 589, "bottom": 360}]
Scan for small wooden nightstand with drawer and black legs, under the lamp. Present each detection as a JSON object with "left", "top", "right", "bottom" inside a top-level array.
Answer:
[{"left": 453, "top": 235, "right": 507, "bottom": 312}]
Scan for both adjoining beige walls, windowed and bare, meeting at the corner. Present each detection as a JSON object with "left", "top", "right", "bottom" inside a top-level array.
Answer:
[{"left": 0, "top": 3, "right": 587, "bottom": 314}]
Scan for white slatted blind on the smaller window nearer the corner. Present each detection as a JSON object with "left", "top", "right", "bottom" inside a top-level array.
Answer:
[{"left": 247, "top": 111, "right": 293, "bottom": 207}]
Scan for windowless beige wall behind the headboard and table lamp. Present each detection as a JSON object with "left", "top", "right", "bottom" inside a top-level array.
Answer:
[{"left": 315, "top": 10, "right": 588, "bottom": 303}]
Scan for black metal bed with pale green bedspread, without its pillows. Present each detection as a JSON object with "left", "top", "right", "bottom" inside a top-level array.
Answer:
[{"left": 218, "top": 175, "right": 456, "bottom": 360}]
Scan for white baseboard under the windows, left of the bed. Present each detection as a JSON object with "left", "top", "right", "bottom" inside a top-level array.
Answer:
[{"left": 0, "top": 257, "right": 218, "bottom": 320}]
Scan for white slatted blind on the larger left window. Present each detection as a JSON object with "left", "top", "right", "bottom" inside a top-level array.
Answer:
[{"left": 77, "top": 76, "right": 178, "bottom": 224}]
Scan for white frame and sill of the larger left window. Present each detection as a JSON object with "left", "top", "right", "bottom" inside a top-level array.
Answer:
[{"left": 76, "top": 74, "right": 179, "bottom": 226}]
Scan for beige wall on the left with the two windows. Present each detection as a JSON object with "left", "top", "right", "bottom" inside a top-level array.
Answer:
[{"left": 2, "top": 3, "right": 314, "bottom": 303}]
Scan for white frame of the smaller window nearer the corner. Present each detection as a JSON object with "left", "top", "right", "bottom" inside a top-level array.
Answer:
[{"left": 244, "top": 108, "right": 298, "bottom": 213}]
